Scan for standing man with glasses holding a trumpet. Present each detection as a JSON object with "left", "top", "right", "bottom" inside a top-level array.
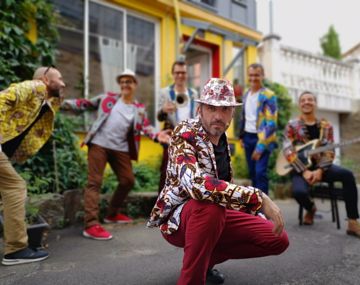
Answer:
[{"left": 158, "top": 61, "right": 198, "bottom": 193}]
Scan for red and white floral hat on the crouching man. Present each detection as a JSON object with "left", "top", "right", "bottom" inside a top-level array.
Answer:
[{"left": 195, "top": 78, "right": 242, "bottom": 107}]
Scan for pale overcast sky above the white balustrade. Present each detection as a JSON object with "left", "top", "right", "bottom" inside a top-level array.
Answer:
[{"left": 257, "top": 0, "right": 360, "bottom": 53}]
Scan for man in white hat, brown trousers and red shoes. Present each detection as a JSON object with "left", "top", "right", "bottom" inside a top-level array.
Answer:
[{"left": 64, "top": 69, "right": 169, "bottom": 240}]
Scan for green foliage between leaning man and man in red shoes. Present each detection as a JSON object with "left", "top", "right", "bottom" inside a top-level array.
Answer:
[{"left": 15, "top": 114, "right": 87, "bottom": 194}]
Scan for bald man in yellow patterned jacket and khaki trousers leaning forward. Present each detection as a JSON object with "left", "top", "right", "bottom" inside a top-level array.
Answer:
[{"left": 0, "top": 66, "right": 65, "bottom": 265}]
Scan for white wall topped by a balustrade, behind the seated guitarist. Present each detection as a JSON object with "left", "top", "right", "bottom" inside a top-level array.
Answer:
[{"left": 258, "top": 35, "right": 360, "bottom": 169}]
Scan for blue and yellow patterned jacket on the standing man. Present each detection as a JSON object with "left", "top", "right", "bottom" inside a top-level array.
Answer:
[{"left": 240, "top": 88, "right": 278, "bottom": 153}]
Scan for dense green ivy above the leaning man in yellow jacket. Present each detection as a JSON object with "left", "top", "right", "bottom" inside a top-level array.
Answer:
[{"left": 0, "top": 0, "right": 58, "bottom": 90}]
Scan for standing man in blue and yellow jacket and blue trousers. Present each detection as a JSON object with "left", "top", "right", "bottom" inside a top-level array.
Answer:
[{"left": 240, "top": 63, "right": 277, "bottom": 193}]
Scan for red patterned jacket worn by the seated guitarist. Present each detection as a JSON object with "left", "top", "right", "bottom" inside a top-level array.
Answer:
[{"left": 283, "top": 116, "right": 334, "bottom": 173}]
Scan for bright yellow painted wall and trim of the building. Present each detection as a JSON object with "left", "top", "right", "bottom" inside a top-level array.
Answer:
[{"left": 95, "top": 0, "right": 261, "bottom": 165}]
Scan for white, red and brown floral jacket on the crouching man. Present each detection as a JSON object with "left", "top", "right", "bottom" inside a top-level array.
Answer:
[{"left": 147, "top": 117, "right": 262, "bottom": 234}]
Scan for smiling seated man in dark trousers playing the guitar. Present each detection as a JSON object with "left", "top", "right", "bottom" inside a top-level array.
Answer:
[{"left": 284, "top": 91, "right": 360, "bottom": 237}]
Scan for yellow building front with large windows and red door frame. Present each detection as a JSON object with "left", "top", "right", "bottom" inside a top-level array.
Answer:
[{"left": 51, "top": 0, "right": 261, "bottom": 160}]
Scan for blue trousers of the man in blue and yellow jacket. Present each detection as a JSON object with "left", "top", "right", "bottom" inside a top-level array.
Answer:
[{"left": 243, "top": 132, "right": 270, "bottom": 194}]
